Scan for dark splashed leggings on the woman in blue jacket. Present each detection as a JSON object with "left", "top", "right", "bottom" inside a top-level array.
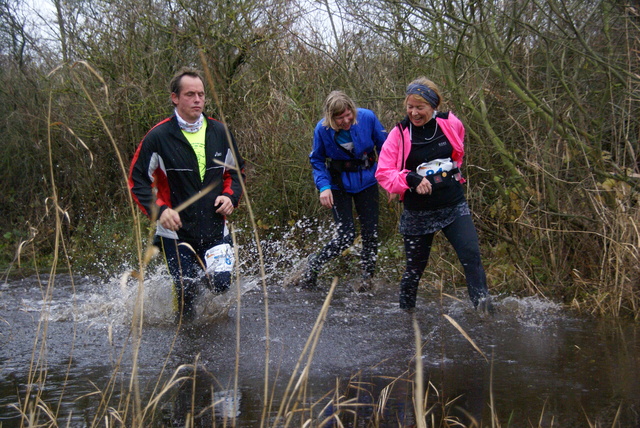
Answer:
[{"left": 311, "top": 184, "right": 379, "bottom": 277}]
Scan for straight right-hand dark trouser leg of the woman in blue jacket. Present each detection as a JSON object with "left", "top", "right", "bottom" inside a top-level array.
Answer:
[{"left": 353, "top": 184, "right": 380, "bottom": 278}]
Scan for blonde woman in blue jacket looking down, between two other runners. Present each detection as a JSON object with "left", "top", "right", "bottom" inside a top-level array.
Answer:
[{"left": 293, "top": 91, "right": 387, "bottom": 291}]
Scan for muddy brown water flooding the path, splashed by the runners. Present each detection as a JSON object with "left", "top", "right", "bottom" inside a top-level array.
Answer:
[{"left": 0, "top": 272, "right": 640, "bottom": 427}]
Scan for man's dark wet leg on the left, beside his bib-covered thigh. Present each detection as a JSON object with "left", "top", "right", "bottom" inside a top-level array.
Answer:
[{"left": 159, "top": 237, "right": 202, "bottom": 315}]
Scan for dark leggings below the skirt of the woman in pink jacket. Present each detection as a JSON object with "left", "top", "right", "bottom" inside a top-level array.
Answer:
[{"left": 400, "top": 215, "right": 488, "bottom": 309}]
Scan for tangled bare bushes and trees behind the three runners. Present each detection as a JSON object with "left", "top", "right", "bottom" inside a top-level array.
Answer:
[{"left": 0, "top": 0, "right": 640, "bottom": 319}]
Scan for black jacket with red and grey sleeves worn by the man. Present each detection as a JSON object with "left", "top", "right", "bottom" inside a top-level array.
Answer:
[{"left": 129, "top": 115, "right": 244, "bottom": 245}]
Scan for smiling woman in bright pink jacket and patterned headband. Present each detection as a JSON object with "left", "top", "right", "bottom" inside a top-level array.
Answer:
[{"left": 376, "top": 77, "right": 493, "bottom": 312}]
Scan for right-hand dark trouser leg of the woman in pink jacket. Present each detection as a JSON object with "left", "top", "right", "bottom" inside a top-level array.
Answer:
[{"left": 442, "top": 215, "right": 489, "bottom": 306}]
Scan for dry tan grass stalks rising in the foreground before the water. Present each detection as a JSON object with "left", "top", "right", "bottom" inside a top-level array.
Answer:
[{"left": 7, "top": 58, "right": 632, "bottom": 428}]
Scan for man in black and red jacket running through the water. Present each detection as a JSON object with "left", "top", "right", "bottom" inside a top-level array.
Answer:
[{"left": 129, "top": 68, "right": 244, "bottom": 320}]
